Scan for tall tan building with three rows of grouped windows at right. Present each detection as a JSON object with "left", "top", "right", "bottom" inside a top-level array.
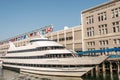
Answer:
[{"left": 81, "top": 0, "right": 120, "bottom": 54}]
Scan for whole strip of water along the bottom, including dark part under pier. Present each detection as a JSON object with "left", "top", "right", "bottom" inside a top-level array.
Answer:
[{"left": 0, "top": 69, "right": 120, "bottom": 80}]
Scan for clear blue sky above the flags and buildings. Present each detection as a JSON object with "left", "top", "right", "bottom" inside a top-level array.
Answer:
[{"left": 0, "top": 0, "right": 109, "bottom": 40}]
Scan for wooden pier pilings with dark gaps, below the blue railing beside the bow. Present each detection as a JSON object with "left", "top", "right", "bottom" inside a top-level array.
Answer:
[{"left": 82, "top": 58, "right": 120, "bottom": 80}]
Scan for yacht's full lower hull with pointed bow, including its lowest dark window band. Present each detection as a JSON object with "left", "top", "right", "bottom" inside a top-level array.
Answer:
[{"left": 3, "top": 56, "right": 107, "bottom": 77}]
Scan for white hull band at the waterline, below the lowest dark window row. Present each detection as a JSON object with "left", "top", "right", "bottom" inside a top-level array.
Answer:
[{"left": 4, "top": 65, "right": 93, "bottom": 77}]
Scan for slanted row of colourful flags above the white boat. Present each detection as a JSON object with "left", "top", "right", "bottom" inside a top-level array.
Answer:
[{"left": 0, "top": 25, "right": 53, "bottom": 45}]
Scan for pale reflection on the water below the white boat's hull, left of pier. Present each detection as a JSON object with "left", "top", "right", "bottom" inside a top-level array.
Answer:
[{"left": 0, "top": 69, "right": 83, "bottom": 80}]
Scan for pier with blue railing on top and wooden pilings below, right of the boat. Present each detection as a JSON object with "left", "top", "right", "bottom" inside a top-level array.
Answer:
[{"left": 78, "top": 48, "right": 120, "bottom": 76}]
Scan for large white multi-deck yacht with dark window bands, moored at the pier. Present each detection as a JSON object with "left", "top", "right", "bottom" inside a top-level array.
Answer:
[{"left": 1, "top": 38, "right": 108, "bottom": 77}]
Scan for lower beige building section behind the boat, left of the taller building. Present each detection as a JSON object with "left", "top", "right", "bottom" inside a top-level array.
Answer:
[{"left": 45, "top": 25, "right": 82, "bottom": 51}]
